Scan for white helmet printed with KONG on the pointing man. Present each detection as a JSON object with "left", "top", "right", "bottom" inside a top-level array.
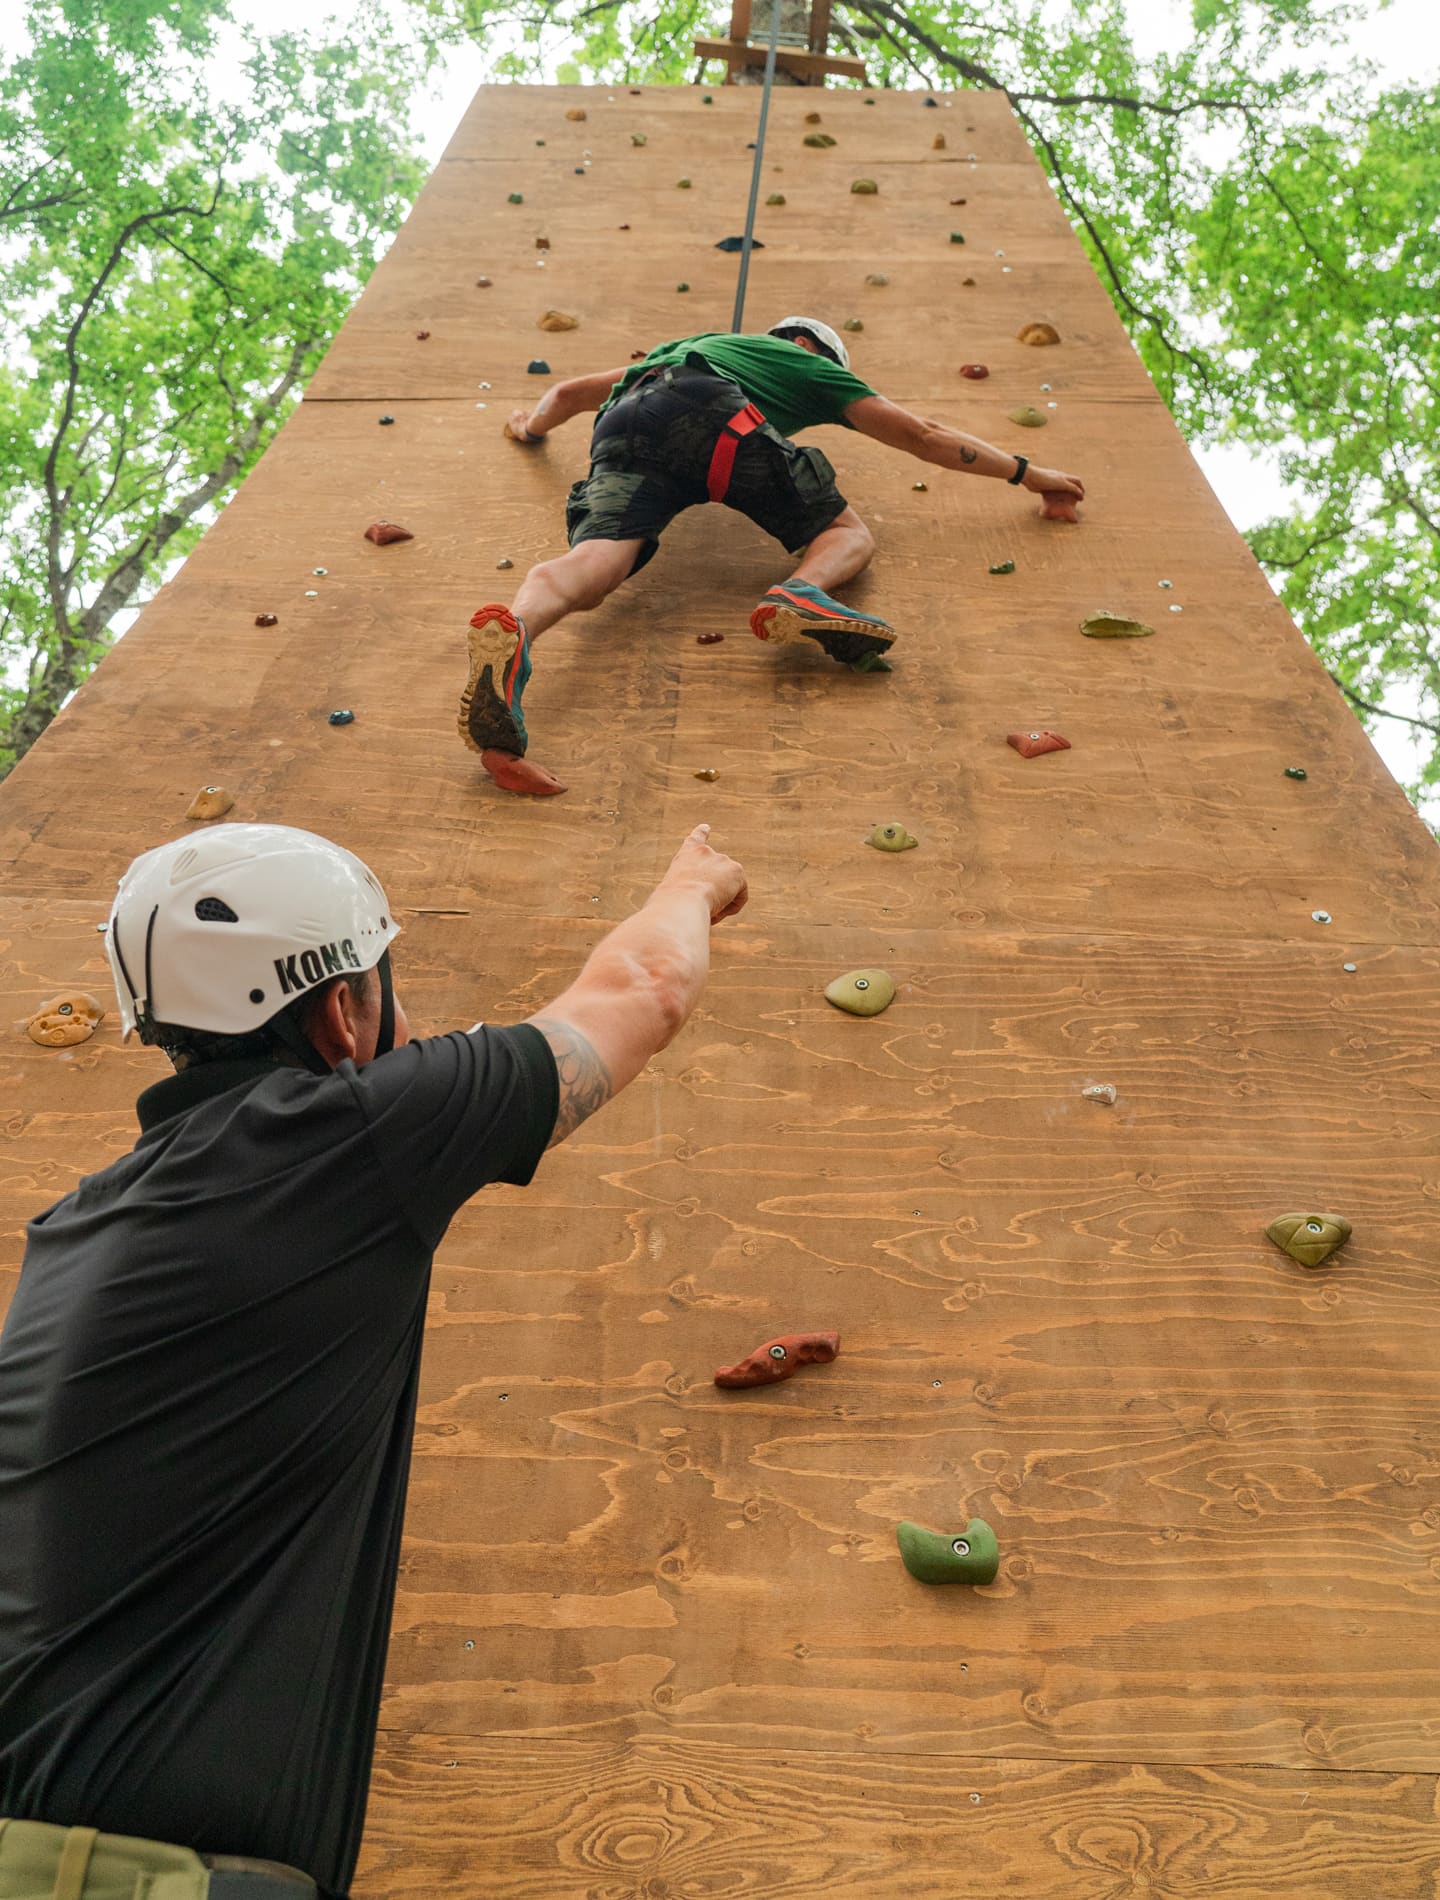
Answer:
[{"left": 104, "top": 825, "right": 401, "bottom": 1041}]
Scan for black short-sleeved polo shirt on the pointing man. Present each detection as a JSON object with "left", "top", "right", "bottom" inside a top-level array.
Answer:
[{"left": 0, "top": 1026, "right": 559, "bottom": 1896}]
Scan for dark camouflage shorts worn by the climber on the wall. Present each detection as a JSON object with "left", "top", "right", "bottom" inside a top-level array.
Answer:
[{"left": 564, "top": 371, "right": 847, "bottom": 574}]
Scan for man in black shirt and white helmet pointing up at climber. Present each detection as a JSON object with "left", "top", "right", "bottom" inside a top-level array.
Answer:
[{"left": 0, "top": 825, "right": 747, "bottom": 1900}]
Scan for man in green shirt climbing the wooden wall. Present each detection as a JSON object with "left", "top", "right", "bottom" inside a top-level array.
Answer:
[{"left": 460, "top": 317, "right": 1085, "bottom": 796}]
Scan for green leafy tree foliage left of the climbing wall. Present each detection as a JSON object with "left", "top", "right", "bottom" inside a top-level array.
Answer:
[{"left": 0, "top": 0, "right": 420, "bottom": 770}]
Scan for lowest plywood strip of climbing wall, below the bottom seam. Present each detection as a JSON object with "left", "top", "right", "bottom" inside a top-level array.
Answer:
[{"left": 355, "top": 1735, "right": 1440, "bottom": 1900}]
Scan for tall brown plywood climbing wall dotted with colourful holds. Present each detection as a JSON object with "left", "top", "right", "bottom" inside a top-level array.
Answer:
[{"left": 0, "top": 87, "right": 1440, "bottom": 1900}]
